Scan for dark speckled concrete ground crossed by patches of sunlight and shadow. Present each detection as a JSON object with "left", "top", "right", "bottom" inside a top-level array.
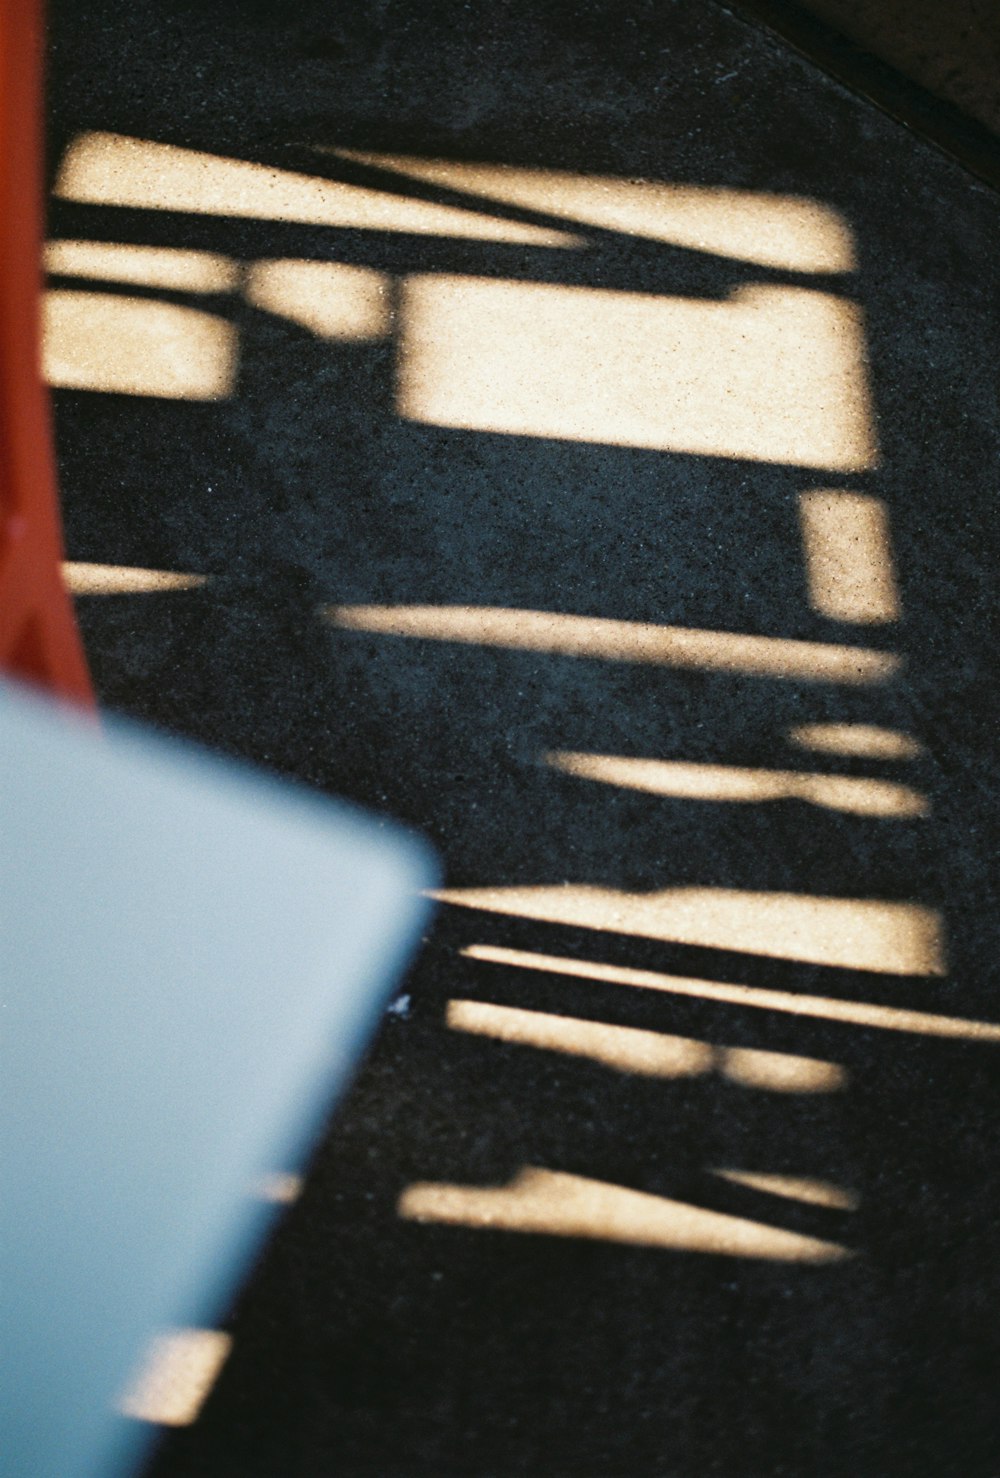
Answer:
[{"left": 42, "top": 0, "right": 1000, "bottom": 1478}]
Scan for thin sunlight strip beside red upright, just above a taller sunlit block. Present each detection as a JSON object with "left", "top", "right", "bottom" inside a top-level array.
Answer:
[{"left": 44, "top": 241, "right": 239, "bottom": 293}]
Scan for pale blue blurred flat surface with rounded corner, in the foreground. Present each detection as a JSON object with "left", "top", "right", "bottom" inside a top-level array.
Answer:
[{"left": 0, "top": 684, "right": 434, "bottom": 1478}]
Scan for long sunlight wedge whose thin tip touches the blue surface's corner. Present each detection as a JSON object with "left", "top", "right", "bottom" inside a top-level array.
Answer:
[{"left": 433, "top": 882, "right": 947, "bottom": 975}]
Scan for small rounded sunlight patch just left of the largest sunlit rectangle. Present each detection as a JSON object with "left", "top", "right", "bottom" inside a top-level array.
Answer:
[{"left": 245, "top": 259, "right": 391, "bottom": 341}]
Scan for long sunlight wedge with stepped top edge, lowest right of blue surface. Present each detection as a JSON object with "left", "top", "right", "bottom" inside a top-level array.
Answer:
[{"left": 399, "top": 1166, "right": 851, "bottom": 1262}]
